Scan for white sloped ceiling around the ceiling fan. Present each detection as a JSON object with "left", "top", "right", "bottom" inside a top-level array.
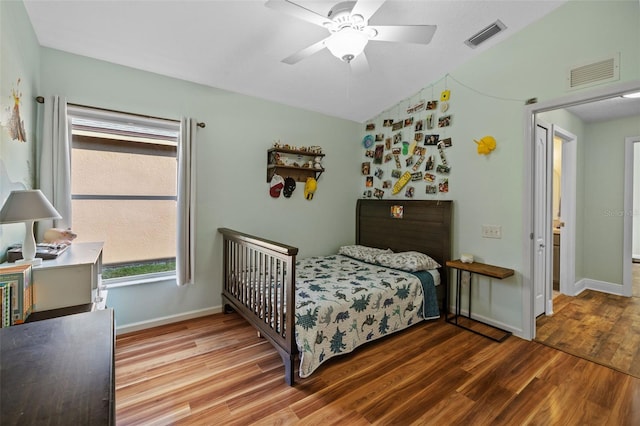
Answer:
[{"left": 24, "top": 0, "right": 564, "bottom": 122}]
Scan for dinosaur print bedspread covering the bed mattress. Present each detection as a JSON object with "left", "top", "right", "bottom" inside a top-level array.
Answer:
[{"left": 295, "top": 255, "right": 437, "bottom": 377}]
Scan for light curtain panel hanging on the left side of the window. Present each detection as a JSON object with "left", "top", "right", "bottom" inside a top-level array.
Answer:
[{"left": 38, "top": 96, "right": 71, "bottom": 241}]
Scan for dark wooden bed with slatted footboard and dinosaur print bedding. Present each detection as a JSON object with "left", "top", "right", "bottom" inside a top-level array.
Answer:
[{"left": 219, "top": 199, "right": 452, "bottom": 385}]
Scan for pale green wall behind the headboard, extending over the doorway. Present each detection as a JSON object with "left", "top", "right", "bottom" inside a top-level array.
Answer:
[{"left": 357, "top": 1, "right": 640, "bottom": 334}]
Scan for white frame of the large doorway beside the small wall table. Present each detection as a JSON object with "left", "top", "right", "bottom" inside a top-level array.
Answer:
[{"left": 522, "top": 81, "right": 640, "bottom": 340}]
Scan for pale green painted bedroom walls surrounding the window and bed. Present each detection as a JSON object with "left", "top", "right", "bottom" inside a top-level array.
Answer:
[{"left": 0, "top": 0, "right": 640, "bottom": 333}]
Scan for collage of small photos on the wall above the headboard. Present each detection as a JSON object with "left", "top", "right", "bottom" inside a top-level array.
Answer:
[{"left": 361, "top": 90, "right": 453, "bottom": 199}]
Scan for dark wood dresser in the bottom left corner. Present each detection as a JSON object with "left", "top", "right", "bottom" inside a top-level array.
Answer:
[{"left": 0, "top": 309, "right": 115, "bottom": 426}]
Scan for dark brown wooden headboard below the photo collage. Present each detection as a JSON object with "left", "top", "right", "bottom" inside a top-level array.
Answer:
[{"left": 356, "top": 199, "right": 453, "bottom": 284}]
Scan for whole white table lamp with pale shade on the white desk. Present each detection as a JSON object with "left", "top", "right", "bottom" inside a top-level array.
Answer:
[{"left": 0, "top": 189, "right": 62, "bottom": 265}]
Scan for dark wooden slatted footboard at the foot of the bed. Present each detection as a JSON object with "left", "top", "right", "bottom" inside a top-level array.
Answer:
[{"left": 218, "top": 228, "right": 298, "bottom": 385}]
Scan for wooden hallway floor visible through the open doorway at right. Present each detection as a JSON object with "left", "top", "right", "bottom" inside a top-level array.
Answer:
[{"left": 536, "top": 264, "right": 640, "bottom": 378}]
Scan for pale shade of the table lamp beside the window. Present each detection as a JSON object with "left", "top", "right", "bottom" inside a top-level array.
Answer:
[{"left": 0, "top": 189, "right": 62, "bottom": 223}]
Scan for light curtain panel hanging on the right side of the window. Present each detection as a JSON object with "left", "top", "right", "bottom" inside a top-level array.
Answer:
[{"left": 176, "top": 118, "right": 197, "bottom": 286}]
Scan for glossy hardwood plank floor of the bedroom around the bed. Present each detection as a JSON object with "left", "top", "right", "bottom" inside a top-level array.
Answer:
[{"left": 116, "top": 313, "right": 640, "bottom": 425}]
